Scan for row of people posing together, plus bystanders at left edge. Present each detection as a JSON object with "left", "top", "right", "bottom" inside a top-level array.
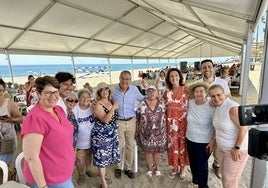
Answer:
[{"left": 0, "top": 59, "right": 248, "bottom": 188}]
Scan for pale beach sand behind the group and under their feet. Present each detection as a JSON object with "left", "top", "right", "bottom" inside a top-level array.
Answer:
[{"left": 6, "top": 64, "right": 261, "bottom": 188}]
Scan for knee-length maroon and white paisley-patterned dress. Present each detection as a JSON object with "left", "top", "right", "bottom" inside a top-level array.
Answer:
[{"left": 137, "top": 100, "right": 167, "bottom": 153}]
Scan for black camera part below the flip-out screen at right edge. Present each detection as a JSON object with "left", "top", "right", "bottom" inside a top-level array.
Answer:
[{"left": 248, "top": 127, "right": 268, "bottom": 161}]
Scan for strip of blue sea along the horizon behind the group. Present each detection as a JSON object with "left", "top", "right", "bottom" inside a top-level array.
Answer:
[{"left": 0, "top": 63, "right": 193, "bottom": 78}]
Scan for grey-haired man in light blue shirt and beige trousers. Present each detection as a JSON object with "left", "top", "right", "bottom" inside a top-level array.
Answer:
[{"left": 112, "top": 70, "right": 144, "bottom": 179}]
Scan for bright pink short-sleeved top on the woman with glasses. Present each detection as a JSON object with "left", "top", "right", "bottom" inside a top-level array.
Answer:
[{"left": 21, "top": 103, "right": 75, "bottom": 185}]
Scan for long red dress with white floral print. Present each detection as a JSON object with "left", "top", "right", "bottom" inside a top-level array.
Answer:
[{"left": 166, "top": 86, "right": 189, "bottom": 169}]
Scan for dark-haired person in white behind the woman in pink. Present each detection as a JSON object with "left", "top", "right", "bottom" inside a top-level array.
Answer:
[{"left": 55, "top": 72, "right": 75, "bottom": 116}]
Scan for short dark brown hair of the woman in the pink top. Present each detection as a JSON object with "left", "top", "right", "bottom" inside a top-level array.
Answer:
[{"left": 35, "top": 76, "right": 60, "bottom": 93}]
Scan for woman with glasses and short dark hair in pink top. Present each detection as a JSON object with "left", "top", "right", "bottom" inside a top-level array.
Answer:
[{"left": 21, "top": 76, "right": 75, "bottom": 188}]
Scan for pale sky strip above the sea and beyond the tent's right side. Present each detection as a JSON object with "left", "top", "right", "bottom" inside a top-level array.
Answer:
[{"left": 0, "top": 9, "right": 266, "bottom": 65}]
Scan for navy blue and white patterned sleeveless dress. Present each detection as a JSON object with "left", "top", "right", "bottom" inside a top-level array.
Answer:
[{"left": 91, "top": 105, "right": 120, "bottom": 168}]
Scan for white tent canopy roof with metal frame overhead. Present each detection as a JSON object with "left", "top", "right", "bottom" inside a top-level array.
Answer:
[{"left": 0, "top": 0, "right": 267, "bottom": 58}]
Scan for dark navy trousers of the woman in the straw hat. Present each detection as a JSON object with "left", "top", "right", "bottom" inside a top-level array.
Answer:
[{"left": 186, "top": 139, "right": 210, "bottom": 188}]
